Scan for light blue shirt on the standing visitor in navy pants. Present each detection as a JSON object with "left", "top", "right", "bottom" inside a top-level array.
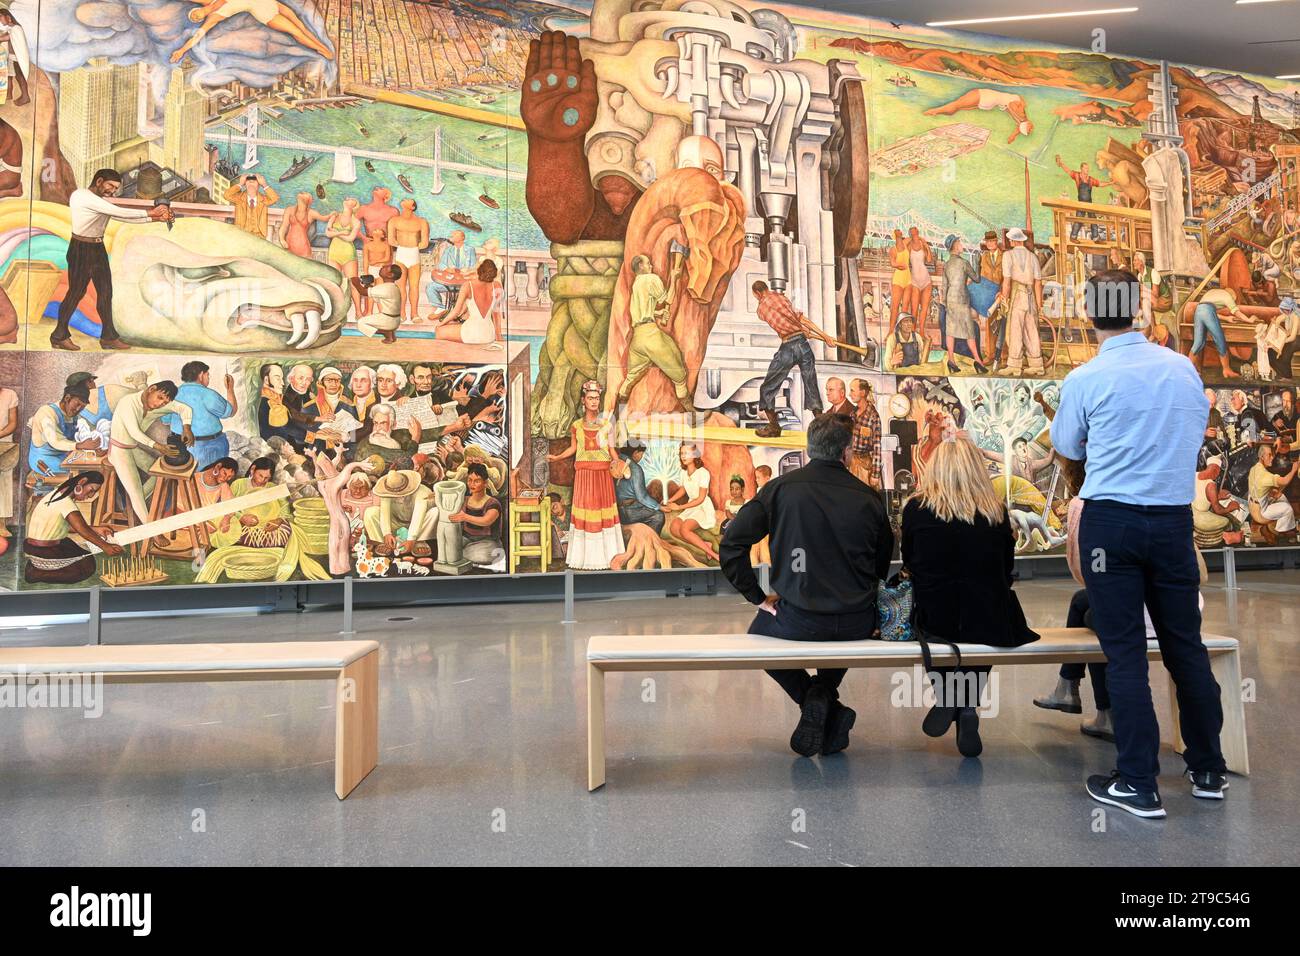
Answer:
[{"left": 1052, "top": 332, "right": 1210, "bottom": 505}]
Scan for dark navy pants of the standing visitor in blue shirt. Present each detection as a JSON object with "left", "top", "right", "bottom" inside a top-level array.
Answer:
[{"left": 1079, "top": 499, "right": 1227, "bottom": 792}]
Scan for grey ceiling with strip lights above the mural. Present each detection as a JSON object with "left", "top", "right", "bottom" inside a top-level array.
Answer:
[{"left": 816, "top": 0, "right": 1300, "bottom": 77}]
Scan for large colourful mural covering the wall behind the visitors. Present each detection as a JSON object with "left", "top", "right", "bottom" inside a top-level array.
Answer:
[{"left": 0, "top": 0, "right": 1300, "bottom": 588}]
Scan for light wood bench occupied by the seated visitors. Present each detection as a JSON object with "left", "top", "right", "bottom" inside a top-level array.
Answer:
[{"left": 586, "top": 627, "right": 1249, "bottom": 791}]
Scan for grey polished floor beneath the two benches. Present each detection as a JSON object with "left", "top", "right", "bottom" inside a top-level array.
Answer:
[{"left": 0, "top": 571, "right": 1300, "bottom": 866}]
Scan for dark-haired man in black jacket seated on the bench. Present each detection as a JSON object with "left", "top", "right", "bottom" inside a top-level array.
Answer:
[{"left": 719, "top": 415, "right": 894, "bottom": 757}]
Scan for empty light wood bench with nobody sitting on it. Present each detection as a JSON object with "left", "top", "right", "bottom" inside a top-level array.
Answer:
[{"left": 0, "top": 641, "right": 380, "bottom": 800}]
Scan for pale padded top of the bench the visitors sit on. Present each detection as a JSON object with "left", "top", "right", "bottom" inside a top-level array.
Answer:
[{"left": 586, "top": 627, "right": 1238, "bottom": 662}]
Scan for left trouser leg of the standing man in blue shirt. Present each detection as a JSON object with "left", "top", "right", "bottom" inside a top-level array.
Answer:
[{"left": 1079, "top": 501, "right": 1160, "bottom": 793}]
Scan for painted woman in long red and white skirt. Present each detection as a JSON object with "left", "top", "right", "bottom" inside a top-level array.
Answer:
[{"left": 546, "top": 381, "right": 625, "bottom": 571}]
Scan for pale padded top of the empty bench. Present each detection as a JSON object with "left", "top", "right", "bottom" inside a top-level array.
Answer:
[{"left": 0, "top": 641, "right": 380, "bottom": 674}]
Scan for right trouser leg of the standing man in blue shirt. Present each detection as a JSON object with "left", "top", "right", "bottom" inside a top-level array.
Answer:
[{"left": 1144, "top": 510, "right": 1227, "bottom": 774}]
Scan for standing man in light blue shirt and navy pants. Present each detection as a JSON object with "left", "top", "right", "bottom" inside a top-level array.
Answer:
[{"left": 1052, "top": 271, "right": 1227, "bottom": 817}]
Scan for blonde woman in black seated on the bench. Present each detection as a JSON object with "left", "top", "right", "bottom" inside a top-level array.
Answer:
[{"left": 902, "top": 424, "right": 1039, "bottom": 757}]
